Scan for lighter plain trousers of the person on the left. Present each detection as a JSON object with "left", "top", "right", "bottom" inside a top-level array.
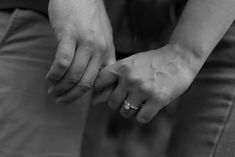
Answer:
[{"left": 0, "top": 9, "right": 90, "bottom": 157}]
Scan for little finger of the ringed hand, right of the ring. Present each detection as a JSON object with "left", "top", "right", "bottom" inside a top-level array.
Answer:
[{"left": 136, "top": 101, "right": 161, "bottom": 123}]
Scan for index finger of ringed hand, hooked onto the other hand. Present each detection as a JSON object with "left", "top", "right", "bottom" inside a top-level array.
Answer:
[{"left": 95, "top": 64, "right": 118, "bottom": 90}]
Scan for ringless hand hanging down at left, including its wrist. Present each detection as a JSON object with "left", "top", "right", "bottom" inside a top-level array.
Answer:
[{"left": 46, "top": 0, "right": 115, "bottom": 104}]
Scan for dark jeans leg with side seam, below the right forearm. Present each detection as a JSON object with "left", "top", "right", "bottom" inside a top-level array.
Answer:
[{"left": 168, "top": 24, "right": 235, "bottom": 157}]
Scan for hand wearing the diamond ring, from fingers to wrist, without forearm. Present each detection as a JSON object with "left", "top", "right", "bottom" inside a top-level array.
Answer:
[{"left": 94, "top": 45, "right": 196, "bottom": 123}]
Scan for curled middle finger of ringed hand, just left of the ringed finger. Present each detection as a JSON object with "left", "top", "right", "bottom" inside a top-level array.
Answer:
[{"left": 108, "top": 82, "right": 127, "bottom": 109}]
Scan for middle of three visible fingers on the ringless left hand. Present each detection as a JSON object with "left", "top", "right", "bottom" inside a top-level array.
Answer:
[{"left": 48, "top": 47, "right": 91, "bottom": 96}]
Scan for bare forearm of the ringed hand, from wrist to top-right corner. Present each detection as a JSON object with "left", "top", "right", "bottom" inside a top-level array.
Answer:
[{"left": 170, "top": 0, "right": 235, "bottom": 71}]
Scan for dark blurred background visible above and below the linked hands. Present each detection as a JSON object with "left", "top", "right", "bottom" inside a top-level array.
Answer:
[{"left": 83, "top": 0, "right": 186, "bottom": 157}]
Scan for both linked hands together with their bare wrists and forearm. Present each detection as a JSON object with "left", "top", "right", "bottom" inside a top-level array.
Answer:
[{"left": 47, "top": 0, "right": 235, "bottom": 123}]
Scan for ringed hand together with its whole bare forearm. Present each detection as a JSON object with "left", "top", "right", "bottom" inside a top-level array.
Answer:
[{"left": 93, "top": 0, "right": 235, "bottom": 123}]
